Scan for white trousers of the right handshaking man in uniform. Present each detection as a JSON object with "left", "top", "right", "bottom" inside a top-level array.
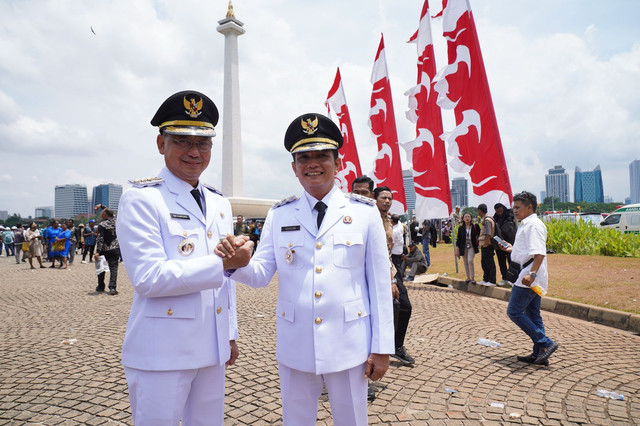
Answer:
[{"left": 278, "top": 363, "right": 367, "bottom": 426}]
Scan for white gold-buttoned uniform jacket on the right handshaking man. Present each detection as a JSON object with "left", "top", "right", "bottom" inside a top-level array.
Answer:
[{"left": 232, "top": 188, "right": 395, "bottom": 374}]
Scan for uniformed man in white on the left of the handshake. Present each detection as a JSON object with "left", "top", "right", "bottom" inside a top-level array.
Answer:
[{"left": 117, "top": 91, "right": 251, "bottom": 426}]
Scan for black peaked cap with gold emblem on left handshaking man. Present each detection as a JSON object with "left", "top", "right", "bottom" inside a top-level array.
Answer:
[{"left": 151, "top": 90, "right": 218, "bottom": 137}]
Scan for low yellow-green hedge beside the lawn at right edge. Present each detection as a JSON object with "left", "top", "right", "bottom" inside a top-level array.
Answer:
[{"left": 547, "top": 220, "right": 640, "bottom": 257}]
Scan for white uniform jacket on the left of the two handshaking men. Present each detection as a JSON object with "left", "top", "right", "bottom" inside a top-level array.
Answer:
[{"left": 117, "top": 168, "right": 238, "bottom": 370}]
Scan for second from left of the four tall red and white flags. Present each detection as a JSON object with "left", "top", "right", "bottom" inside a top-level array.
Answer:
[{"left": 369, "top": 36, "right": 407, "bottom": 215}]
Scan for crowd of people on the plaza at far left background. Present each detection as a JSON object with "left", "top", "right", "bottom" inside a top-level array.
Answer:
[{"left": 0, "top": 204, "right": 121, "bottom": 295}]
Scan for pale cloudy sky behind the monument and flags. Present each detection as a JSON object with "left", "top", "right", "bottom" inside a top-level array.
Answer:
[{"left": 0, "top": 0, "right": 640, "bottom": 217}]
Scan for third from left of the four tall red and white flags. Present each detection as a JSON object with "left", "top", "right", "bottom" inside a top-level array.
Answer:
[{"left": 402, "top": 0, "right": 451, "bottom": 222}]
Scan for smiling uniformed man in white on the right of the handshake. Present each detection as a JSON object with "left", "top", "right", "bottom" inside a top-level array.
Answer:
[{"left": 218, "top": 114, "right": 394, "bottom": 426}]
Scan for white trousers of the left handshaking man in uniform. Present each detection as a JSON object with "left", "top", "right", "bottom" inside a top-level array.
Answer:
[{"left": 124, "top": 365, "right": 225, "bottom": 426}]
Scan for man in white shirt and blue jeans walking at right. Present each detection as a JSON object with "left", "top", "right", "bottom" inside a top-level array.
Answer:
[{"left": 504, "top": 191, "right": 558, "bottom": 365}]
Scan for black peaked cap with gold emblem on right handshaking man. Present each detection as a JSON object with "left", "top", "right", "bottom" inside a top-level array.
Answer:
[{"left": 284, "top": 113, "right": 342, "bottom": 154}]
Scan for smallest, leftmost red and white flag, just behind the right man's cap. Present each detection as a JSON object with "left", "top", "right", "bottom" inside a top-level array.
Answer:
[{"left": 324, "top": 68, "right": 362, "bottom": 192}]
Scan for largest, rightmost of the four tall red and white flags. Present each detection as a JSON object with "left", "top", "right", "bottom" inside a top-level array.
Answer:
[{"left": 434, "top": 0, "right": 513, "bottom": 210}]
